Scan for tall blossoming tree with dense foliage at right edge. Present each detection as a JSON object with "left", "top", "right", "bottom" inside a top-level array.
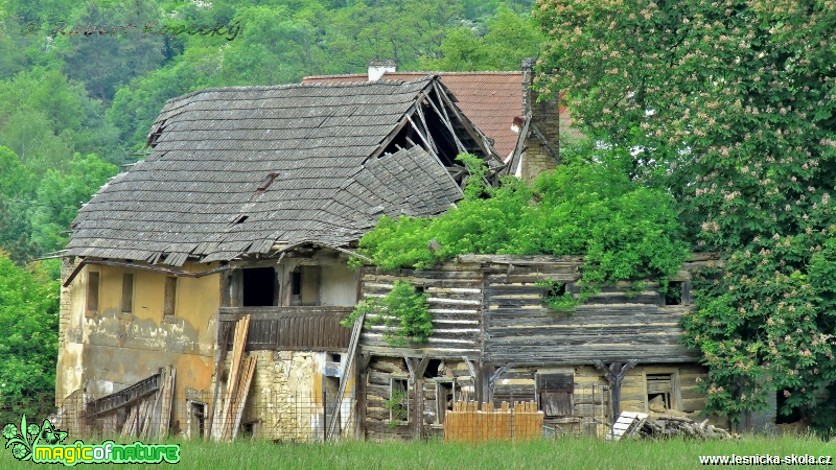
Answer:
[{"left": 536, "top": 0, "right": 836, "bottom": 425}]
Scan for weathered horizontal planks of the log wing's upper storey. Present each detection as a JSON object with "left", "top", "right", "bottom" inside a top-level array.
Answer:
[{"left": 361, "top": 255, "right": 711, "bottom": 365}]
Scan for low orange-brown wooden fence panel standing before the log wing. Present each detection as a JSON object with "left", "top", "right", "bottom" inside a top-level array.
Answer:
[{"left": 444, "top": 401, "right": 543, "bottom": 442}]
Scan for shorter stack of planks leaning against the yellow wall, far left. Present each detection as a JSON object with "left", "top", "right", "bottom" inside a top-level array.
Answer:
[{"left": 119, "top": 366, "right": 176, "bottom": 440}]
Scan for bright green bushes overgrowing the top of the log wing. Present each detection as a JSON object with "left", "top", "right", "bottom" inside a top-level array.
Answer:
[{"left": 360, "top": 153, "right": 688, "bottom": 306}]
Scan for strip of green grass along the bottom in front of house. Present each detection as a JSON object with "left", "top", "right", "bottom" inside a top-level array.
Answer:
[{"left": 0, "top": 437, "right": 836, "bottom": 470}]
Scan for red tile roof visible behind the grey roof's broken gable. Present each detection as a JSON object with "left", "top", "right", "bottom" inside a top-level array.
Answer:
[{"left": 302, "top": 72, "right": 524, "bottom": 159}]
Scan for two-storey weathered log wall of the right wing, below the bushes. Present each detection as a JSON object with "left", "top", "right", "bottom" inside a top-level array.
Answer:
[{"left": 357, "top": 255, "right": 724, "bottom": 438}]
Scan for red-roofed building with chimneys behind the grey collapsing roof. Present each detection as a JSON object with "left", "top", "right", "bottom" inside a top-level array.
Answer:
[{"left": 302, "top": 59, "right": 579, "bottom": 181}]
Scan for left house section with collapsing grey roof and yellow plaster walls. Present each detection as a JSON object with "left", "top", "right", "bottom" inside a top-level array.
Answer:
[{"left": 56, "top": 76, "right": 502, "bottom": 439}]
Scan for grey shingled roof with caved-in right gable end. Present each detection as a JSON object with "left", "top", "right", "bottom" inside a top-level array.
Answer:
[{"left": 67, "top": 76, "right": 501, "bottom": 266}]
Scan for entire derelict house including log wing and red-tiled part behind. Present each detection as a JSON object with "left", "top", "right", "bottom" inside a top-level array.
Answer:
[{"left": 56, "top": 67, "right": 740, "bottom": 440}]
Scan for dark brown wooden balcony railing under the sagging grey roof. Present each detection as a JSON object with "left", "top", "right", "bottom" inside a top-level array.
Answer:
[{"left": 218, "top": 306, "right": 352, "bottom": 352}]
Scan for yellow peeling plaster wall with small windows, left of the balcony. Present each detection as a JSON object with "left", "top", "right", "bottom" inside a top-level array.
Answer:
[{"left": 56, "top": 261, "right": 220, "bottom": 429}]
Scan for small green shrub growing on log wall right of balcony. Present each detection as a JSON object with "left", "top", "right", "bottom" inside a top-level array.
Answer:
[{"left": 342, "top": 280, "right": 433, "bottom": 346}]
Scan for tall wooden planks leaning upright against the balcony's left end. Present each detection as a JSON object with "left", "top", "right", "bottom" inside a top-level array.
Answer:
[{"left": 209, "top": 315, "right": 256, "bottom": 441}]
